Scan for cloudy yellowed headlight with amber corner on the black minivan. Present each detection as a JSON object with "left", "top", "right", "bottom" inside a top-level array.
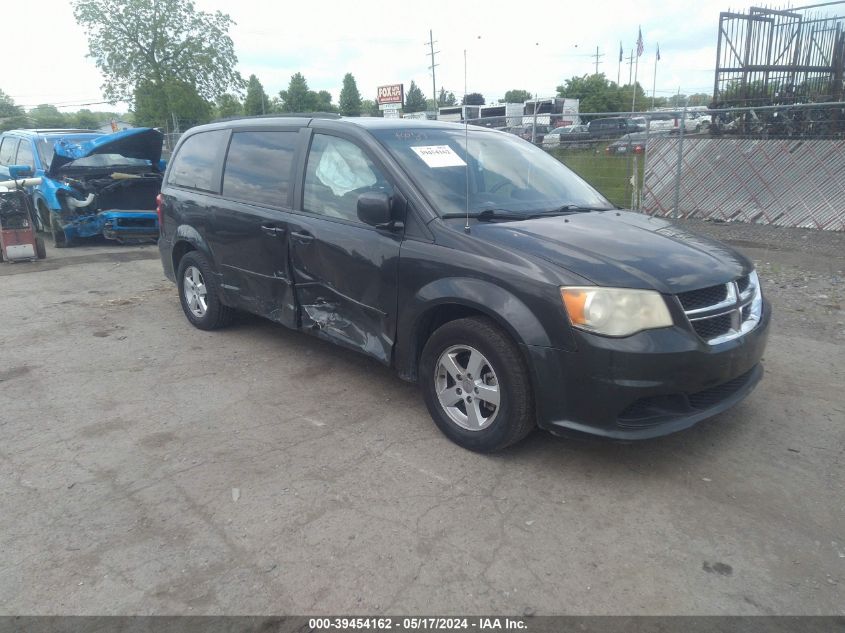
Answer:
[{"left": 560, "top": 286, "right": 672, "bottom": 336}]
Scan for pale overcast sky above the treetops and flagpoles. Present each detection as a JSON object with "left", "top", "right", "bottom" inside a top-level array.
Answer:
[{"left": 6, "top": 0, "right": 780, "bottom": 110}]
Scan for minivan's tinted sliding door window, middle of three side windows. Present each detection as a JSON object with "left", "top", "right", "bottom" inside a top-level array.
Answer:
[{"left": 223, "top": 132, "right": 299, "bottom": 207}]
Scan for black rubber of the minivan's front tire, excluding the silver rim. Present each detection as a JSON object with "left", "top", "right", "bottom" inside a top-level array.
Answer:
[{"left": 420, "top": 316, "right": 536, "bottom": 453}]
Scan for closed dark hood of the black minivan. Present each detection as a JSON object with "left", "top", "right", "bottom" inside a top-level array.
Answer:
[{"left": 472, "top": 211, "right": 753, "bottom": 294}]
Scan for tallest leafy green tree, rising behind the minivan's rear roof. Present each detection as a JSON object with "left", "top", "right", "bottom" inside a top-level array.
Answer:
[{"left": 73, "top": 0, "right": 242, "bottom": 110}]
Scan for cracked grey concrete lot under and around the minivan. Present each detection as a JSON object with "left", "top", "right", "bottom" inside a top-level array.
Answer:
[{"left": 0, "top": 230, "right": 845, "bottom": 615}]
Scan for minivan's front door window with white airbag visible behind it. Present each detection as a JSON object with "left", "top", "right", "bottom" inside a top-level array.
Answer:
[{"left": 302, "top": 134, "right": 393, "bottom": 222}]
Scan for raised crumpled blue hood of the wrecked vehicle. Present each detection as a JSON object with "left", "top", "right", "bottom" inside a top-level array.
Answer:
[{"left": 47, "top": 127, "right": 164, "bottom": 176}]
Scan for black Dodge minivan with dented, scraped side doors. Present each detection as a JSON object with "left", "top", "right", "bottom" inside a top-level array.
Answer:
[{"left": 159, "top": 115, "right": 770, "bottom": 451}]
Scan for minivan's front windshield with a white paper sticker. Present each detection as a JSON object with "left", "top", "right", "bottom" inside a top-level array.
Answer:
[{"left": 373, "top": 128, "right": 613, "bottom": 215}]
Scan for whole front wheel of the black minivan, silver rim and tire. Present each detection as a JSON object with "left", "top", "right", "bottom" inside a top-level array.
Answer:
[{"left": 420, "top": 317, "right": 535, "bottom": 453}]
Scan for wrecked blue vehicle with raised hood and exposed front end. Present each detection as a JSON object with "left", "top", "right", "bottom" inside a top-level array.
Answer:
[{"left": 0, "top": 128, "right": 164, "bottom": 248}]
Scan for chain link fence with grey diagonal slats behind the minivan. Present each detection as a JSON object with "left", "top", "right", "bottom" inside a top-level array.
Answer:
[{"left": 468, "top": 102, "right": 845, "bottom": 231}]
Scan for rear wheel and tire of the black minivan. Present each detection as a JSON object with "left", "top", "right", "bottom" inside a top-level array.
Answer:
[{"left": 176, "top": 251, "right": 235, "bottom": 330}]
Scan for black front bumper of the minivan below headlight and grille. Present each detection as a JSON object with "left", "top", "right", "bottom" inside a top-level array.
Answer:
[{"left": 525, "top": 301, "right": 771, "bottom": 440}]
